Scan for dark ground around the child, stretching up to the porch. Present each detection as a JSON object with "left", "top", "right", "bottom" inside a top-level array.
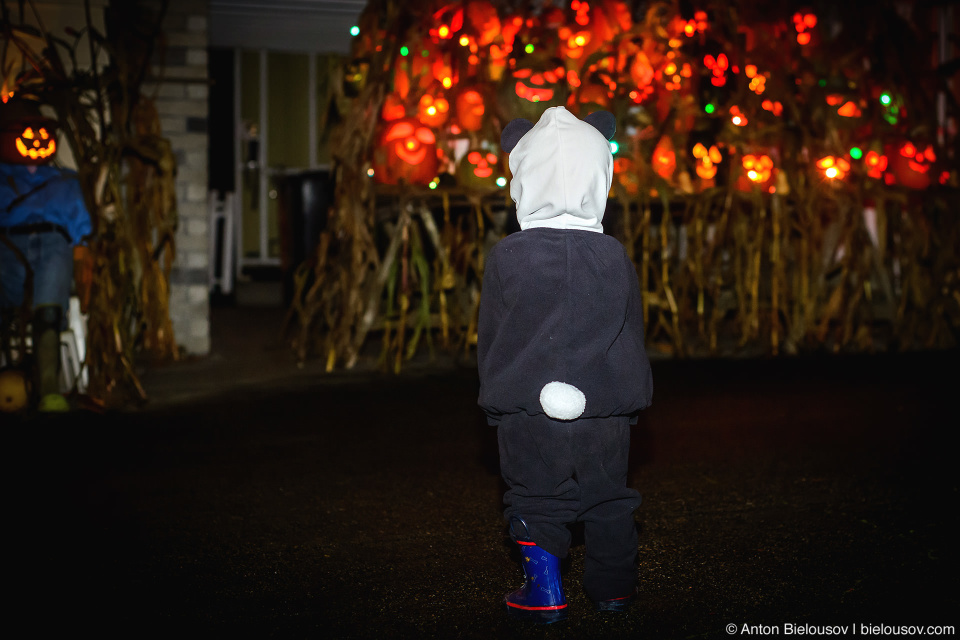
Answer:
[{"left": 4, "top": 311, "right": 960, "bottom": 638}]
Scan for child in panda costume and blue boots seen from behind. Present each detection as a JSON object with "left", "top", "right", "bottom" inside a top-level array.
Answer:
[{"left": 477, "top": 107, "right": 653, "bottom": 623}]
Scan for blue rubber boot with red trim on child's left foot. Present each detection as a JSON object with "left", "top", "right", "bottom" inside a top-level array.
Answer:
[{"left": 504, "top": 517, "right": 567, "bottom": 624}]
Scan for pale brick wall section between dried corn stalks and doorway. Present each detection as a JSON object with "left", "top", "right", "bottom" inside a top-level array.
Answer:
[{"left": 146, "top": 0, "right": 210, "bottom": 355}]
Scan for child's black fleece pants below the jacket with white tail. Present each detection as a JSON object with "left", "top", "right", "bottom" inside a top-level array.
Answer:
[{"left": 497, "top": 413, "right": 640, "bottom": 600}]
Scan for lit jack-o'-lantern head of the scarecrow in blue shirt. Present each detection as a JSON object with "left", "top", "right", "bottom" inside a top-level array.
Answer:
[{"left": 0, "top": 101, "right": 57, "bottom": 165}]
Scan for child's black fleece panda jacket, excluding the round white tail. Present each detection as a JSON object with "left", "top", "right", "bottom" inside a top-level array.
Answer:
[{"left": 477, "top": 228, "right": 653, "bottom": 425}]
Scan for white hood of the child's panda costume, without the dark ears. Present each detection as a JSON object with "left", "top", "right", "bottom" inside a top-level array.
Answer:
[{"left": 509, "top": 107, "right": 613, "bottom": 233}]
